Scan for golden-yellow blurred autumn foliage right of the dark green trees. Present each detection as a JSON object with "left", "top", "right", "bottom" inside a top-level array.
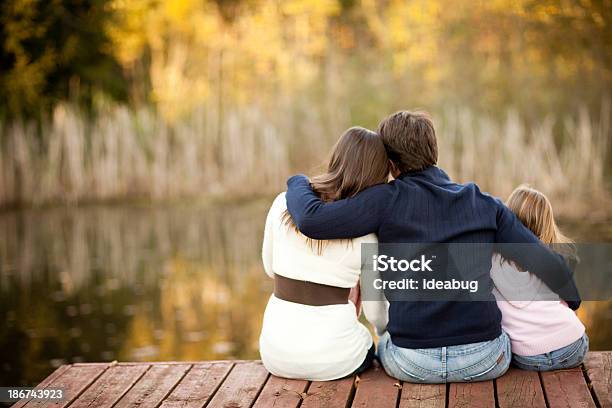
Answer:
[{"left": 103, "top": 0, "right": 609, "bottom": 122}]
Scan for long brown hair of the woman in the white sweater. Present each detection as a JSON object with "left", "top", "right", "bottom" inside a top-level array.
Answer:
[{"left": 283, "top": 127, "right": 390, "bottom": 254}]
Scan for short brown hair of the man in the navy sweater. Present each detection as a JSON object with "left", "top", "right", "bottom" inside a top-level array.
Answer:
[{"left": 378, "top": 111, "right": 438, "bottom": 172}]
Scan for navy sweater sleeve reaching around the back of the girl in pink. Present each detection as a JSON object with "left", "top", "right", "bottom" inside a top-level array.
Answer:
[{"left": 496, "top": 203, "right": 580, "bottom": 310}]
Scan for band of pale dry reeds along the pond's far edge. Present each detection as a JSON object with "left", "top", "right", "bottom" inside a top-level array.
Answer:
[{"left": 0, "top": 102, "right": 611, "bottom": 212}]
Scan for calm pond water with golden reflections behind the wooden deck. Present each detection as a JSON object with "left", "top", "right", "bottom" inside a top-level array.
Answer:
[{"left": 0, "top": 199, "right": 612, "bottom": 385}]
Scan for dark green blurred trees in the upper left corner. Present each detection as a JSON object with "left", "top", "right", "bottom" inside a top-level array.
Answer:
[{"left": 0, "top": 0, "right": 128, "bottom": 117}]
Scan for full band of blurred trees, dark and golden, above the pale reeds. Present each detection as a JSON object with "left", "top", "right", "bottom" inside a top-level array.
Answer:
[{"left": 0, "top": 0, "right": 612, "bottom": 120}]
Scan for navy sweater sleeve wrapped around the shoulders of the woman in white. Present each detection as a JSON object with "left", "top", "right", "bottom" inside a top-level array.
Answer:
[{"left": 286, "top": 174, "right": 392, "bottom": 239}]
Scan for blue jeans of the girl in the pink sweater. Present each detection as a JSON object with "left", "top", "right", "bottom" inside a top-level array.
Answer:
[{"left": 512, "top": 333, "right": 589, "bottom": 371}]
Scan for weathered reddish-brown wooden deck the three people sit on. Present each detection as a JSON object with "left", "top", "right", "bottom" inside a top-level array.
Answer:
[{"left": 14, "top": 352, "right": 612, "bottom": 408}]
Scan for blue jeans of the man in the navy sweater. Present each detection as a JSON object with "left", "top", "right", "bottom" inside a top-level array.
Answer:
[{"left": 378, "top": 333, "right": 512, "bottom": 384}]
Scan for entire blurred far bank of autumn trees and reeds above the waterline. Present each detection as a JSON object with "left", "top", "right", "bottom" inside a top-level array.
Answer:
[{"left": 0, "top": 0, "right": 612, "bottom": 207}]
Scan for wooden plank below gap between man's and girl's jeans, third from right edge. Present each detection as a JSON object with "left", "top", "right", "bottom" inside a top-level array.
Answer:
[{"left": 495, "top": 367, "right": 546, "bottom": 408}]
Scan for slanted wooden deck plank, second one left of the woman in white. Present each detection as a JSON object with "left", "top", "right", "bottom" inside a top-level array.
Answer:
[{"left": 161, "top": 361, "right": 233, "bottom": 408}]
